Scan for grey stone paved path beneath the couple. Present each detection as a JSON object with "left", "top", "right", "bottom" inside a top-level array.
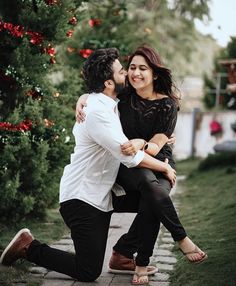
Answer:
[{"left": 27, "top": 177, "right": 184, "bottom": 286}]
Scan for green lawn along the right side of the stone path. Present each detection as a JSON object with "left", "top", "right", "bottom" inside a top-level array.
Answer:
[{"left": 171, "top": 158, "right": 236, "bottom": 286}]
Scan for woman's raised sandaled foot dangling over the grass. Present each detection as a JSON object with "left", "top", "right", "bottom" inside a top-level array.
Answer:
[{"left": 178, "top": 237, "right": 207, "bottom": 263}]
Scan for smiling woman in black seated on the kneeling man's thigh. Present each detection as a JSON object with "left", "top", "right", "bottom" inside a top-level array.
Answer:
[{"left": 77, "top": 46, "right": 207, "bottom": 285}]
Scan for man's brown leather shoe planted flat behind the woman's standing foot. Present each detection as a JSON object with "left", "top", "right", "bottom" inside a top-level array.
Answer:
[{"left": 108, "top": 250, "right": 158, "bottom": 275}]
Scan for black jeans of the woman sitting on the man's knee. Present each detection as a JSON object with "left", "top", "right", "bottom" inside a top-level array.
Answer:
[{"left": 114, "top": 165, "right": 187, "bottom": 266}]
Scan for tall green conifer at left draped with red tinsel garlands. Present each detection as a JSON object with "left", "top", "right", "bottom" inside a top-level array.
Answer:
[{"left": 0, "top": 0, "right": 86, "bottom": 220}]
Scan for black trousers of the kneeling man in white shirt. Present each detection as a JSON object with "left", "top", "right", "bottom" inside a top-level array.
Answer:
[{"left": 27, "top": 192, "right": 145, "bottom": 282}]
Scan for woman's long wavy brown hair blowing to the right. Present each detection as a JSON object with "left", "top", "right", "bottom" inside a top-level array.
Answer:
[{"left": 128, "top": 45, "right": 180, "bottom": 108}]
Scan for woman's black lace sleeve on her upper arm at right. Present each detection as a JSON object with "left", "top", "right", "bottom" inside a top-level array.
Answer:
[{"left": 156, "top": 102, "right": 178, "bottom": 138}]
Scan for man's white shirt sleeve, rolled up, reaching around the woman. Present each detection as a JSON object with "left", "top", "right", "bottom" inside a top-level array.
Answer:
[{"left": 85, "top": 110, "right": 144, "bottom": 168}]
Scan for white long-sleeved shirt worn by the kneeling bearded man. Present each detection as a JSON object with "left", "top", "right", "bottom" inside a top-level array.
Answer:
[{"left": 60, "top": 93, "right": 144, "bottom": 212}]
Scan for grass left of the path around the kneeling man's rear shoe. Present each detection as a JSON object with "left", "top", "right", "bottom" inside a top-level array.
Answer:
[{"left": 0, "top": 209, "right": 67, "bottom": 286}]
